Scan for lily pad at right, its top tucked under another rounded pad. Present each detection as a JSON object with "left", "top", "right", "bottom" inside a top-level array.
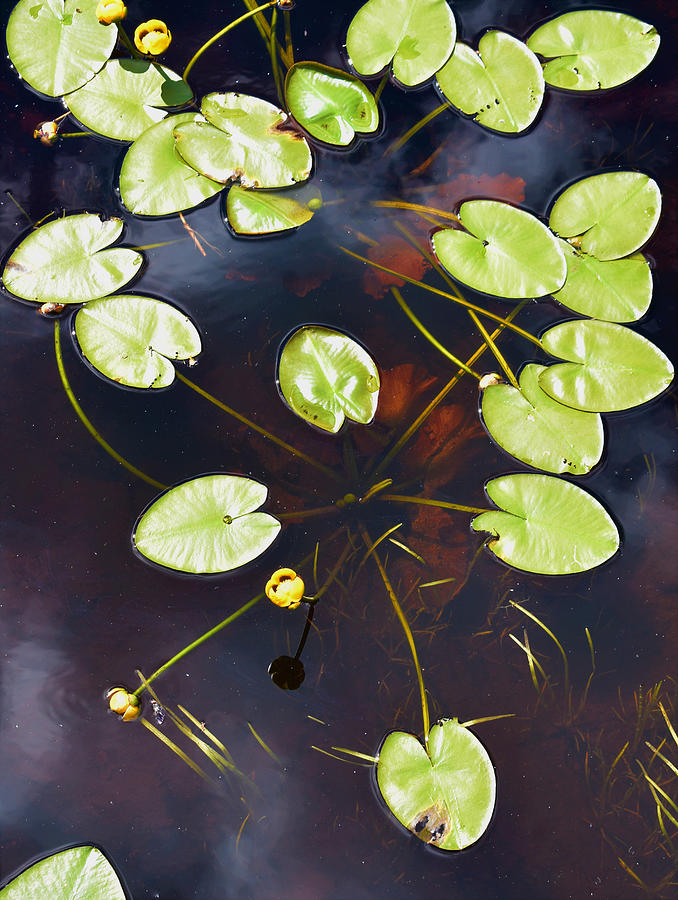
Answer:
[{"left": 553, "top": 241, "right": 652, "bottom": 322}]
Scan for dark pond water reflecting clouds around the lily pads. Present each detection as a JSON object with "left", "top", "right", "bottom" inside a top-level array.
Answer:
[{"left": 0, "top": 0, "right": 678, "bottom": 900}]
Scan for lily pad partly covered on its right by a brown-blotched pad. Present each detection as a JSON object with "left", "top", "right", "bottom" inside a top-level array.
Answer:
[{"left": 120, "top": 113, "right": 223, "bottom": 216}]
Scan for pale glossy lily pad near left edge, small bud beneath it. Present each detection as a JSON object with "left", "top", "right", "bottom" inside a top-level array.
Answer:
[{"left": 2, "top": 213, "right": 143, "bottom": 303}]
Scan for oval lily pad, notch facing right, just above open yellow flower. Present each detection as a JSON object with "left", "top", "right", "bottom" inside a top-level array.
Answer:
[{"left": 133, "top": 475, "right": 280, "bottom": 575}]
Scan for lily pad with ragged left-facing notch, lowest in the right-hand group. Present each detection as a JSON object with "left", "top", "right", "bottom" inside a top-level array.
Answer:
[{"left": 471, "top": 474, "right": 619, "bottom": 575}]
